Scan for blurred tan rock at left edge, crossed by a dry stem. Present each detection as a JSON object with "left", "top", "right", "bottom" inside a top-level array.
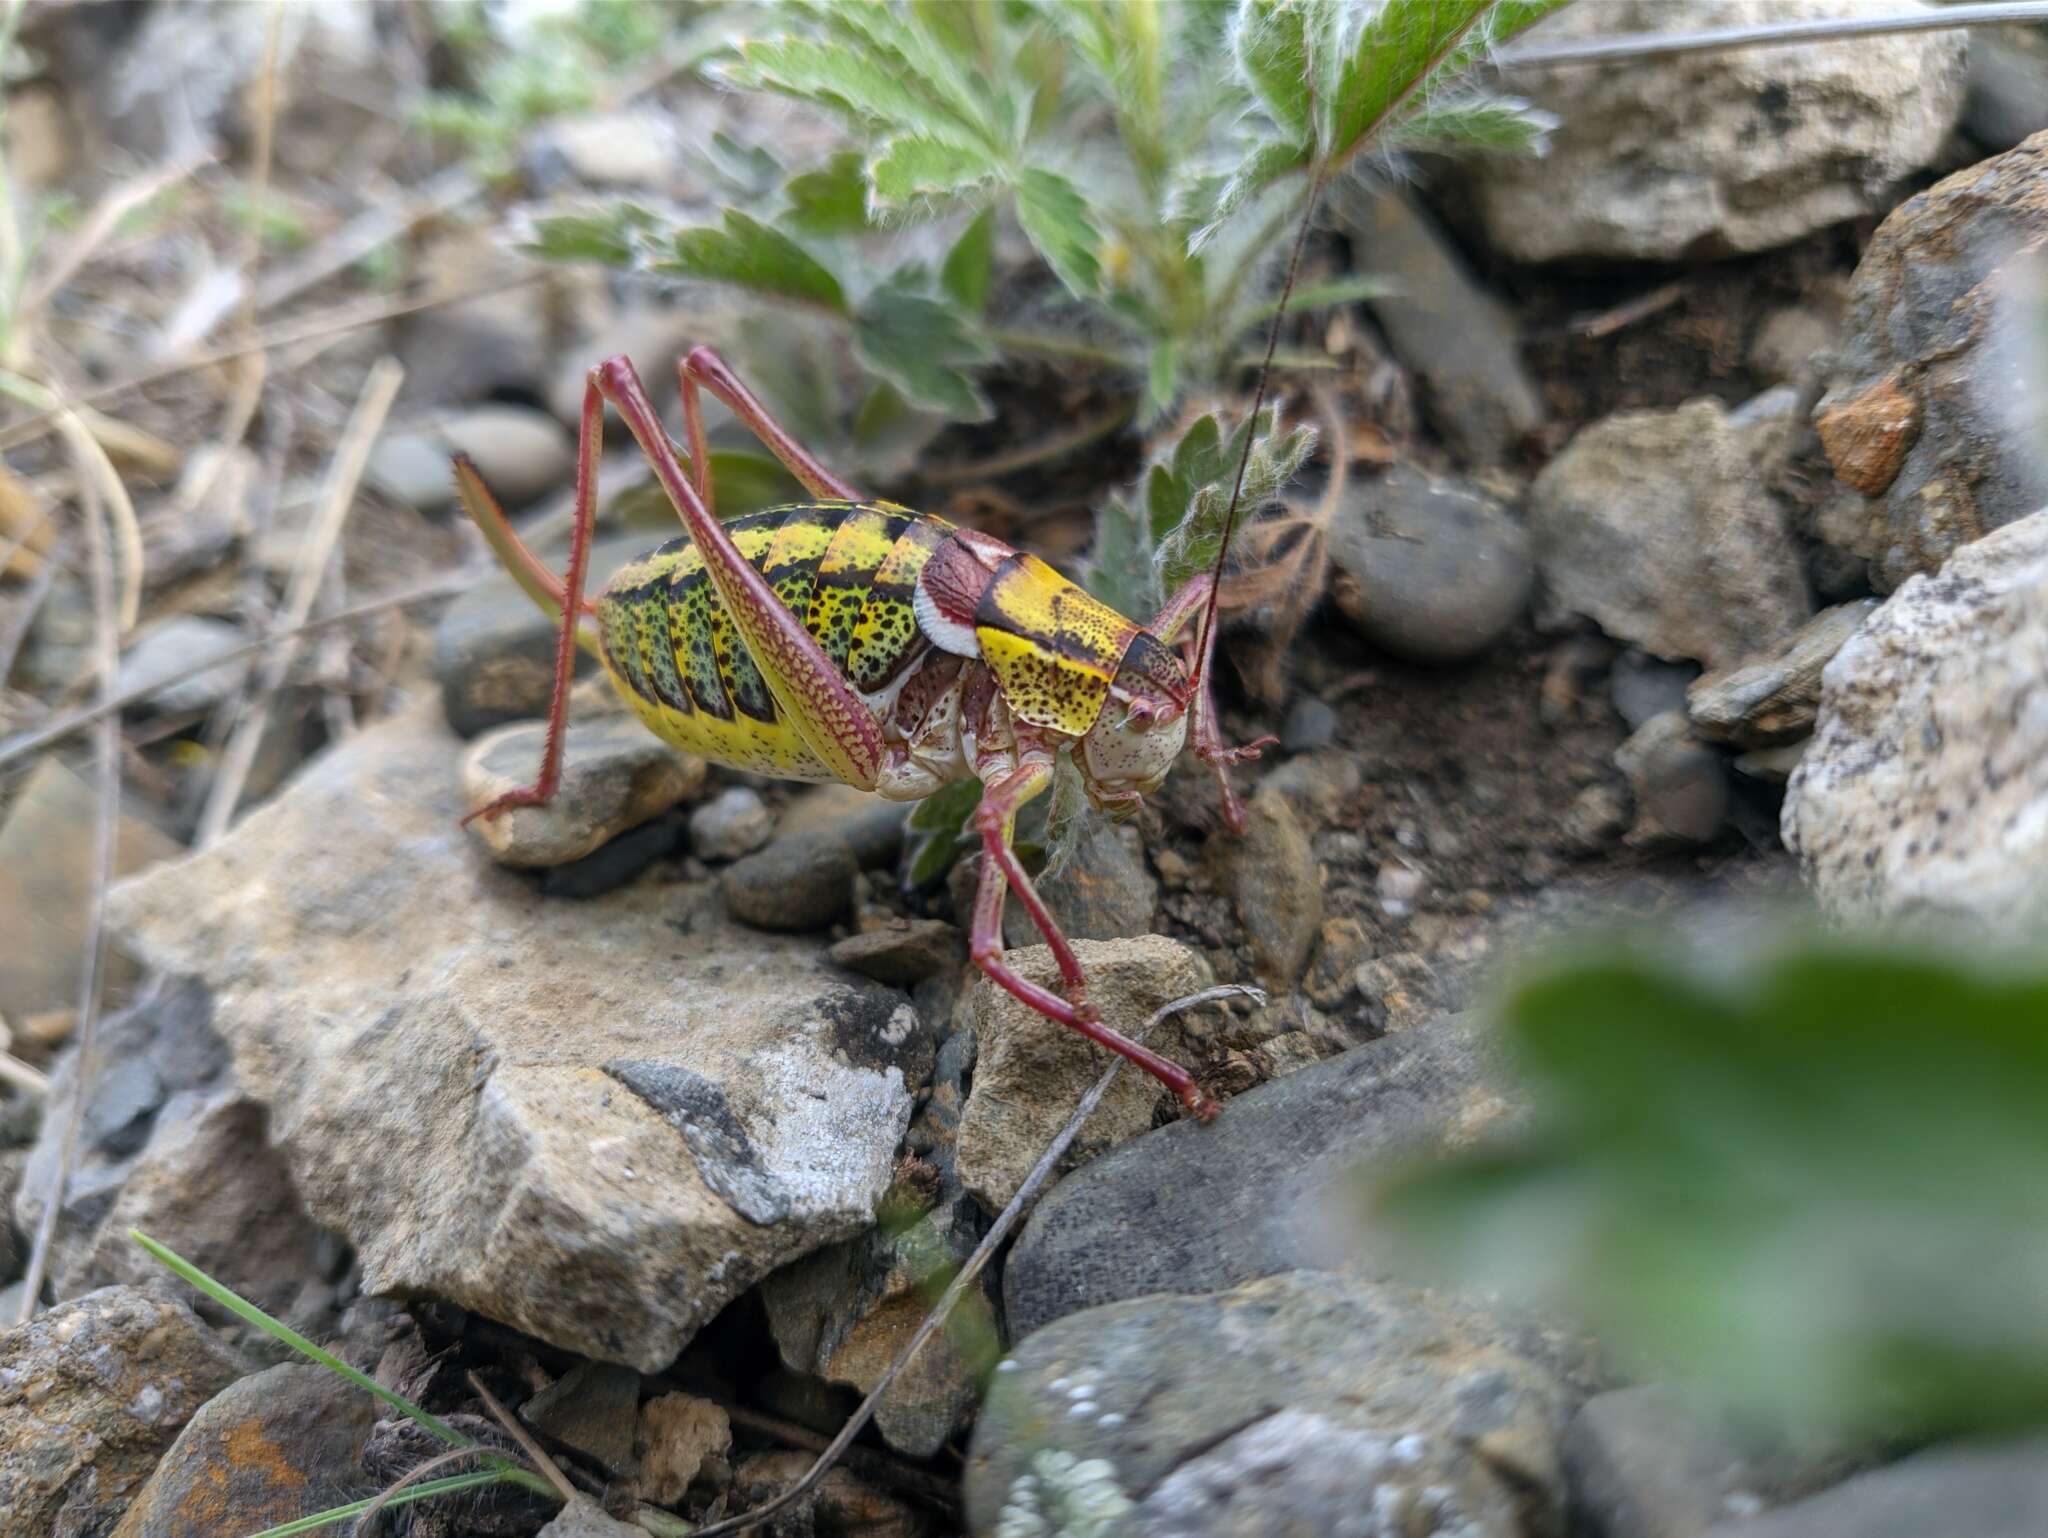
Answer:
[{"left": 0, "top": 758, "right": 178, "bottom": 1022}]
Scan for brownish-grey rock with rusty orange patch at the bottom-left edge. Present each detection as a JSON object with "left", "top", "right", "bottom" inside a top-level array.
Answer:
[{"left": 113, "top": 1362, "right": 377, "bottom": 1538}]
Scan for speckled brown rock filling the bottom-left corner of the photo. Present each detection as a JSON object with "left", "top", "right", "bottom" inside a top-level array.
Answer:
[{"left": 0, "top": 1286, "right": 242, "bottom": 1538}]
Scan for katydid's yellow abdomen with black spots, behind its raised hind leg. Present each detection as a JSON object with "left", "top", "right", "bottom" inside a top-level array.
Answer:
[{"left": 596, "top": 502, "right": 952, "bottom": 780}]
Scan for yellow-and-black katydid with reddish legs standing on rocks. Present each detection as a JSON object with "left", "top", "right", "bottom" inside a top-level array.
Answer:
[{"left": 455, "top": 346, "right": 1272, "bottom": 1120}]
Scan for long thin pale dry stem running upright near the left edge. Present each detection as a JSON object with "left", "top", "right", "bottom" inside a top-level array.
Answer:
[{"left": 16, "top": 479, "right": 121, "bottom": 1325}]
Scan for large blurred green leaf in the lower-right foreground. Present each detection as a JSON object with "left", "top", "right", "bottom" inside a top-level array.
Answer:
[{"left": 1376, "top": 938, "right": 2048, "bottom": 1440}]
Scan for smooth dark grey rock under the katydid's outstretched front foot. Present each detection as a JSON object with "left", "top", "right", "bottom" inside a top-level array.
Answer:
[{"left": 1007, "top": 1018, "right": 1507, "bottom": 1339}]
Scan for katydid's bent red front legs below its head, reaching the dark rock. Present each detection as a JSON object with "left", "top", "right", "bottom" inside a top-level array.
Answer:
[{"left": 969, "top": 760, "right": 1219, "bottom": 1122}]
